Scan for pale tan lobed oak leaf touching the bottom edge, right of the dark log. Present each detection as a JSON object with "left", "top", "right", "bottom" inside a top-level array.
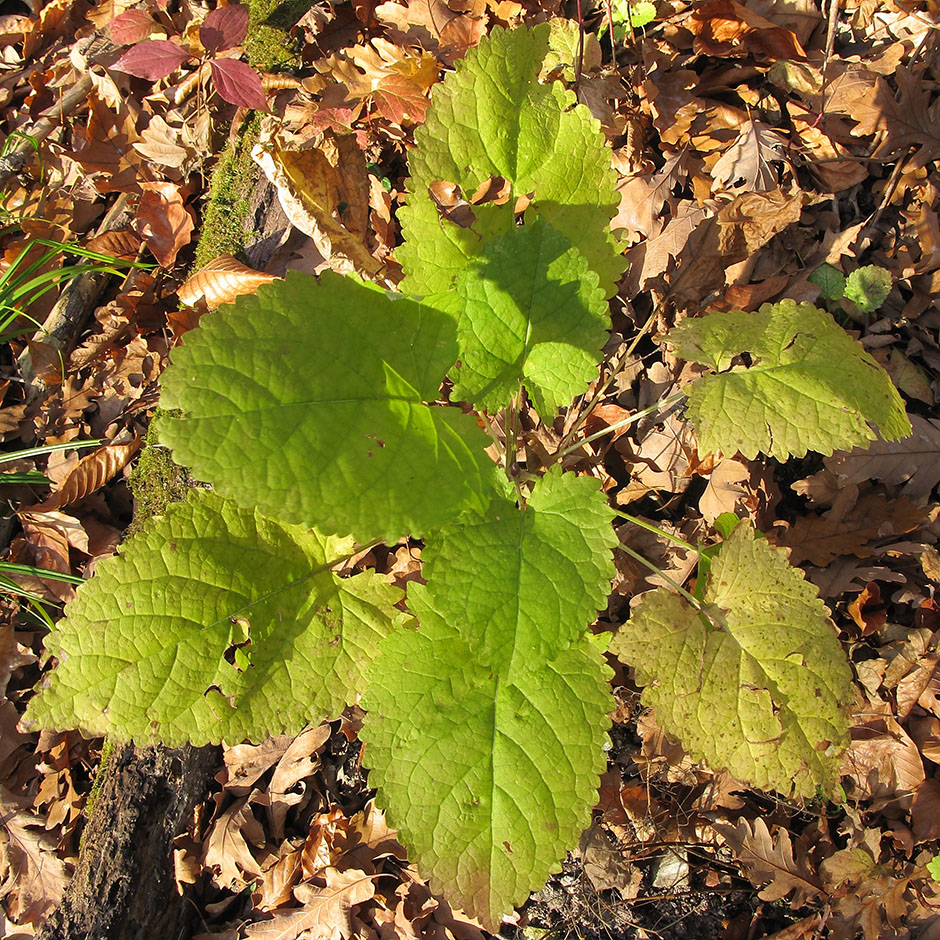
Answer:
[{"left": 245, "top": 868, "right": 375, "bottom": 940}]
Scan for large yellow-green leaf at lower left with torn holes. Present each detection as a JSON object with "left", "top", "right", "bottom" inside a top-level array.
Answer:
[{"left": 26, "top": 491, "right": 402, "bottom": 744}]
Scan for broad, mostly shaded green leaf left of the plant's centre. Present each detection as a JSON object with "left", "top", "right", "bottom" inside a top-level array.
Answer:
[{"left": 161, "top": 272, "right": 492, "bottom": 542}]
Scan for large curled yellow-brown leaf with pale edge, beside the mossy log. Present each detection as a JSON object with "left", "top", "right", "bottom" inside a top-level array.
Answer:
[{"left": 252, "top": 132, "right": 382, "bottom": 279}]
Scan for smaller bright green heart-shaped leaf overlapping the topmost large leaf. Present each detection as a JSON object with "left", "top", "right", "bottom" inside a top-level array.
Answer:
[{"left": 454, "top": 219, "right": 610, "bottom": 418}]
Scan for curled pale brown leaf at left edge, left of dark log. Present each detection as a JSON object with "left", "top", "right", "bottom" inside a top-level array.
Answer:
[{"left": 0, "top": 788, "right": 70, "bottom": 924}]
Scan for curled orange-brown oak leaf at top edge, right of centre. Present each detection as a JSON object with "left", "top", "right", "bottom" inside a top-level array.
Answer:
[{"left": 683, "top": 0, "right": 806, "bottom": 59}]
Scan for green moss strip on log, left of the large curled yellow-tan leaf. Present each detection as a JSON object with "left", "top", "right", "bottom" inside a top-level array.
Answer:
[{"left": 193, "top": 114, "right": 261, "bottom": 271}]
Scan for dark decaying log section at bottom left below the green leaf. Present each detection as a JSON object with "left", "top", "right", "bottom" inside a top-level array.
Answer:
[{"left": 37, "top": 744, "right": 222, "bottom": 940}]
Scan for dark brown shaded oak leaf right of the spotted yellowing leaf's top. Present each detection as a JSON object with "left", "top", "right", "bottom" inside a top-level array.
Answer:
[{"left": 776, "top": 487, "right": 927, "bottom": 567}]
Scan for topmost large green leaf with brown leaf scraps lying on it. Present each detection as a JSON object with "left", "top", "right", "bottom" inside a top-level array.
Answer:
[{"left": 397, "top": 23, "right": 624, "bottom": 295}]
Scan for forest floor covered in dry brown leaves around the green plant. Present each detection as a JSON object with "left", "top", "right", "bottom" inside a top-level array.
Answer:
[{"left": 0, "top": 0, "right": 940, "bottom": 940}]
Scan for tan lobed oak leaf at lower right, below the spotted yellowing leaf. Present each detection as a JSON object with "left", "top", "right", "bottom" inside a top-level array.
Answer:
[{"left": 712, "top": 818, "right": 823, "bottom": 907}]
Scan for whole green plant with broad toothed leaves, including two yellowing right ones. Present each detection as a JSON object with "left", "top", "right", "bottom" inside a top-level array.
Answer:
[{"left": 26, "top": 25, "right": 909, "bottom": 928}]
